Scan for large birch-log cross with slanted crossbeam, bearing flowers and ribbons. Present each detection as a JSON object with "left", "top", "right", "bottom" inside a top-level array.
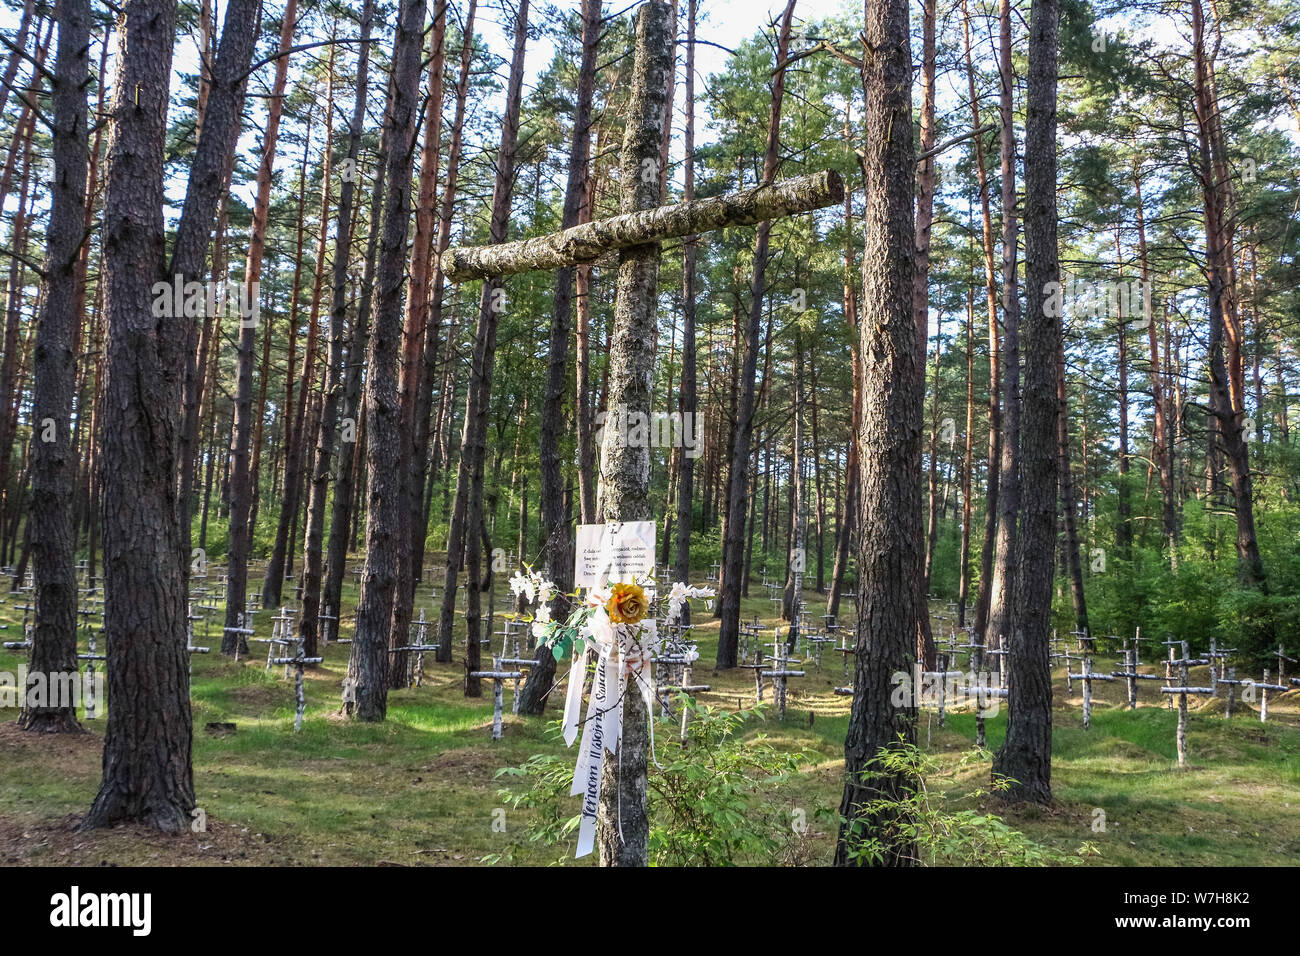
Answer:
[{"left": 441, "top": 0, "right": 844, "bottom": 866}]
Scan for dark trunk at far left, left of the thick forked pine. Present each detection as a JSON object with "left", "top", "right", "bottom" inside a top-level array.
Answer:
[{"left": 18, "top": 0, "right": 90, "bottom": 734}]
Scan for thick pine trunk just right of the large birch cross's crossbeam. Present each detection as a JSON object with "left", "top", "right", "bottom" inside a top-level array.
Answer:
[{"left": 835, "top": 0, "right": 926, "bottom": 866}]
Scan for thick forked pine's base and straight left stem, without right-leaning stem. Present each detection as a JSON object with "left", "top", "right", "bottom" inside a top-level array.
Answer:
[{"left": 82, "top": 0, "right": 194, "bottom": 834}]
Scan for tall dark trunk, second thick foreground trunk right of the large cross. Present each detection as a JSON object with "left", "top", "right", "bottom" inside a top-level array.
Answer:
[{"left": 993, "top": 0, "right": 1061, "bottom": 803}]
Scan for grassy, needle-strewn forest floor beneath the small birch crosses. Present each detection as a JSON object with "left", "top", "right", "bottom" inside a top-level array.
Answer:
[{"left": 0, "top": 572, "right": 1300, "bottom": 866}]
